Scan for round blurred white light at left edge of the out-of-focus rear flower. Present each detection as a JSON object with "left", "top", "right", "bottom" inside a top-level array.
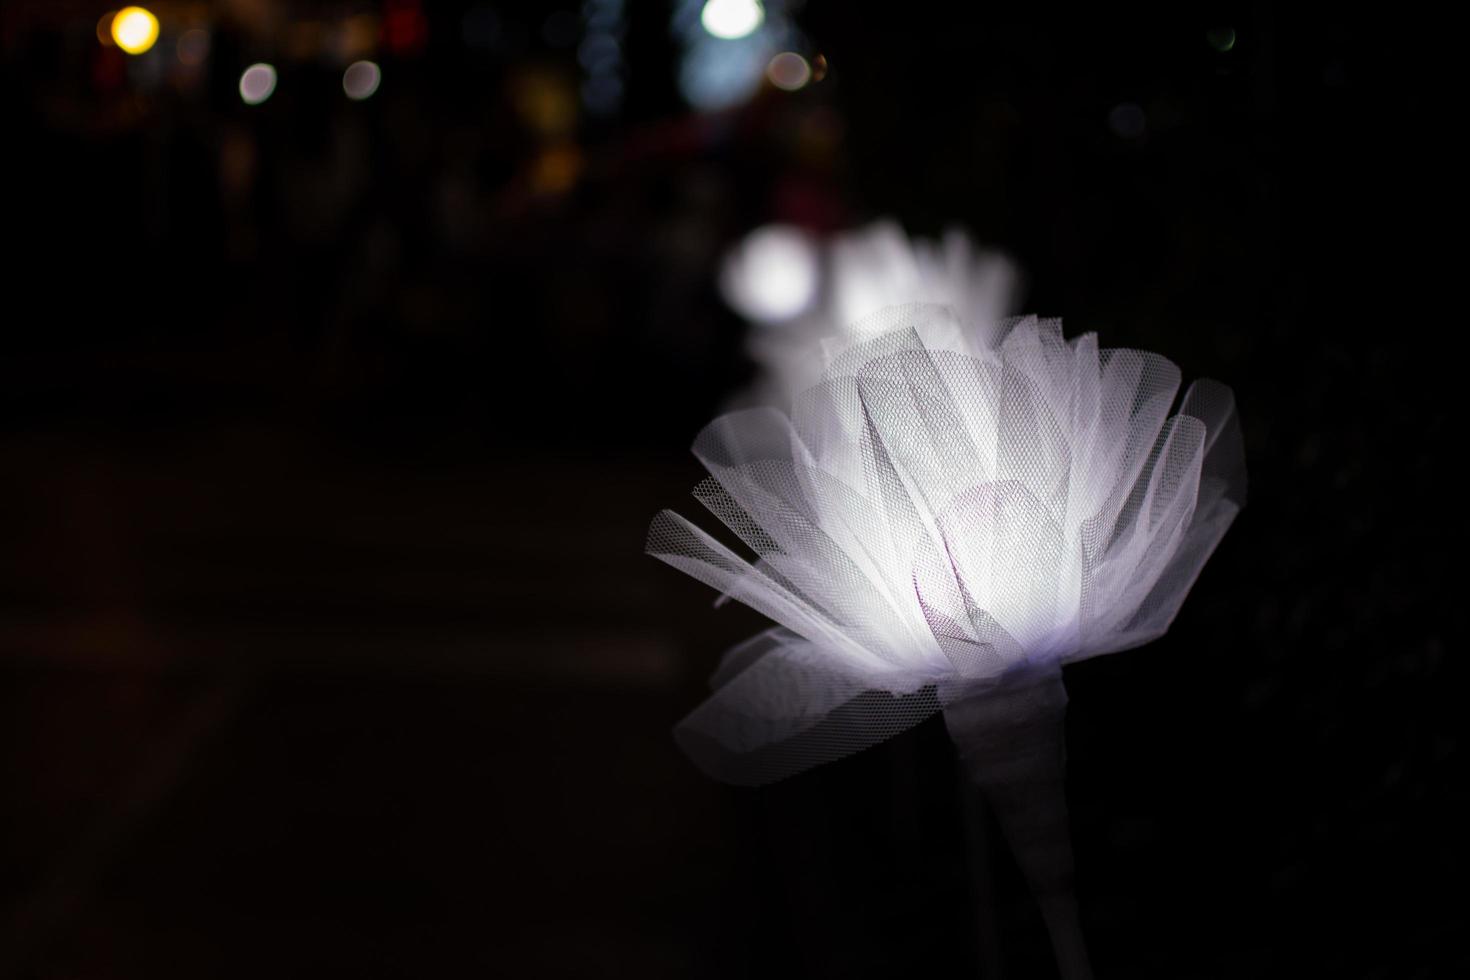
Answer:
[{"left": 720, "top": 225, "right": 820, "bottom": 323}]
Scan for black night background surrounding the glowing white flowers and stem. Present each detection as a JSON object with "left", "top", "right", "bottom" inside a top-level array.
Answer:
[{"left": 0, "top": 0, "right": 1452, "bottom": 977}]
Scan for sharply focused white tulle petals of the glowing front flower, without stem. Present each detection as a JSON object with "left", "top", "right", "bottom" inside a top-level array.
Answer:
[{"left": 648, "top": 306, "right": 1245, "bottom": 785}]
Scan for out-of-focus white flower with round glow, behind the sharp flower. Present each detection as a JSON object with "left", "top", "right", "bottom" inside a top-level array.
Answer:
[{"left": 720, "top": 220, "right": 1019, "bottom": 403}]
